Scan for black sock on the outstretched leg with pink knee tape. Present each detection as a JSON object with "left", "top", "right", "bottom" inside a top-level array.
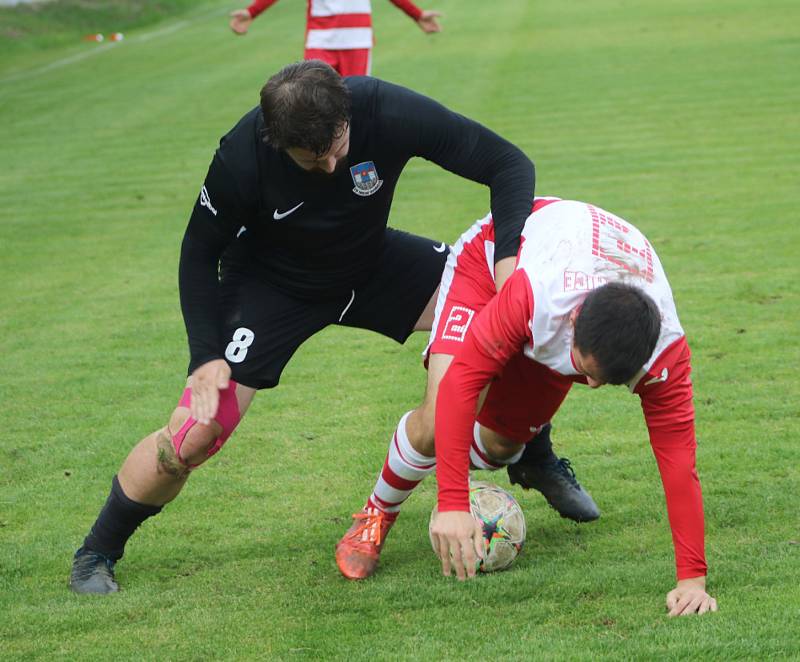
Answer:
[{"left": 83, "top": 476, "right": 162, "bottom": 561}]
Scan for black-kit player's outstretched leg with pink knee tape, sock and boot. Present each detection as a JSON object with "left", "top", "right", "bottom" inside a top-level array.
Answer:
[{"left": 70, "top": 382, "right": 255, "bottom": 593}]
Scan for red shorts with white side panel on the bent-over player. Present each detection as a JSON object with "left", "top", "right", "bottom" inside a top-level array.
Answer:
[{"left": 426, "top": 208, "right": 573, "bottom": 444}]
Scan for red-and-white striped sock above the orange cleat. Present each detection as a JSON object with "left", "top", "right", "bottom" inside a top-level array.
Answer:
[{"left": 365, "top": 412, "right": 436, "bottom": 519}]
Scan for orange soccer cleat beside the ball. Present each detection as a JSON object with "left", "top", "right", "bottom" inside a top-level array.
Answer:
[{"left": 336, "top": 508, "right": 397, "bottom": 579}]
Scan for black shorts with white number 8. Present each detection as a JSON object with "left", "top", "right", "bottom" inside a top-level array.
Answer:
[{"left": 189, "top": 228, "right": 449, "bottom": 389}]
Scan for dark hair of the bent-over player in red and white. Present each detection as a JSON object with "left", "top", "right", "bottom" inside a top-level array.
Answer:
[{"left": 575, "top": 283, "right": 661, "bottom": 384}]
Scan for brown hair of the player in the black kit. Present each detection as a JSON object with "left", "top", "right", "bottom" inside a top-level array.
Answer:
[{"left": 261, "top": 60, "right": 350, "bottom": 156}]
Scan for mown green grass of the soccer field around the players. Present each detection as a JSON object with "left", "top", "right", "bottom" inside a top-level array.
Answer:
[{"left": 0, "top": 0, "right": 800, "bottom": 660}]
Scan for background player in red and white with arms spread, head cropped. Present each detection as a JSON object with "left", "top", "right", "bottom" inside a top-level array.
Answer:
[{"left": 230, "top": 0, "right": 441, "bottom": 76}]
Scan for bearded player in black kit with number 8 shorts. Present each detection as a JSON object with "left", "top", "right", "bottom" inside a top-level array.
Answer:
[{"left": 70, "top": 60, "right": 564, "bottom": 593}]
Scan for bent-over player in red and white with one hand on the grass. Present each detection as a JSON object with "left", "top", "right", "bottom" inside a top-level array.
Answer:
[{"left": 337, "top": 198, "right": 716, "bottom": 615}]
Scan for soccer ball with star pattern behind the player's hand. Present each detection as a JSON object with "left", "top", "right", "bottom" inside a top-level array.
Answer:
[{"left": 428, "top": 481, "right": 526, "bottom": 572}]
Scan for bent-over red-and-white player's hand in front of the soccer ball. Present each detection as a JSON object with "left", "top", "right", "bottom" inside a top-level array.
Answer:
[{"left": 431, "top": 510, "right": 483, "bottom": 581}]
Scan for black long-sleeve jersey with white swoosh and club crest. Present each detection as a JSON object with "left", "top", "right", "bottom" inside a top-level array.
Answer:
[{"left": 179, "top": 77, "right": 534, "bottom": 365}]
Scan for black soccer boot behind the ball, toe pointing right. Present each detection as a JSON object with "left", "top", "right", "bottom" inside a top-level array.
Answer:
[{"left": 507, "top": 423, "right": 600, "bottom": 522}]
